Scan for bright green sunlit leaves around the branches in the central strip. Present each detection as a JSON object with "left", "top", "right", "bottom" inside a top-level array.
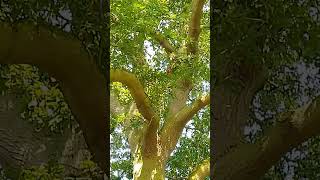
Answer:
[{"left": 110, "top": 0, "right": 210, "bottom": 179}]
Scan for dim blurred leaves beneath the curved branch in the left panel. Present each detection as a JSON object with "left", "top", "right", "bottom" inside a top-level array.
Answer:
[{"left": 0, "top": 65, "right": 73, "bottom": 132}]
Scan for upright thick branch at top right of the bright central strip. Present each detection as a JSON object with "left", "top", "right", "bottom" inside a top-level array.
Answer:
[{"left": 187, "top": 0, "right": 205, "bottom": 54}]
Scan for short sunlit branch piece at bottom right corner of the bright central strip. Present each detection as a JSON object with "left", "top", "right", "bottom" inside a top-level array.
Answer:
[{"left": 189, "top": 159, "right": 210, "bottom": 180}]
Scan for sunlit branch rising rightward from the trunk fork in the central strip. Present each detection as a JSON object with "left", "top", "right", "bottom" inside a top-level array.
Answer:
[{"left": 160, "top": 95, "right": 210, "bottom": 156}]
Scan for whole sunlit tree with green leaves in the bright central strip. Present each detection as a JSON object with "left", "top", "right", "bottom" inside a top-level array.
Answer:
[{"left": 110, "top": 0, "right": 210, "bottom": 179}]
